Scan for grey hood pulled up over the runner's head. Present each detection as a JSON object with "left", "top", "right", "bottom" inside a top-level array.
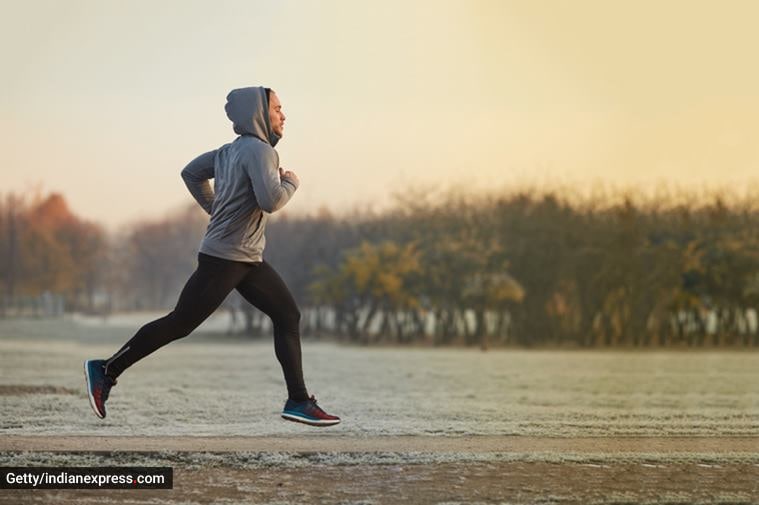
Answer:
[{"left": 224, "top": 86, "right": 280, "bottom": 147}]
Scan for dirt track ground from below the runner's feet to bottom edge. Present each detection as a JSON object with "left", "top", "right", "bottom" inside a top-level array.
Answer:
[{"left": 5, "top": 431, "right": 759, "bottom": 505}]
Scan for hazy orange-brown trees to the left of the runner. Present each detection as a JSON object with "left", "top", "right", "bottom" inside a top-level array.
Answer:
[{"left": 0, "top": 192, "right": 206, "bottom": 315}]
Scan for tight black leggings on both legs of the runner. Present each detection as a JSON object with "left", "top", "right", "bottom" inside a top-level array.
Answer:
[{"left": 106, "top": 253, "right": 308, "bottom": 401}]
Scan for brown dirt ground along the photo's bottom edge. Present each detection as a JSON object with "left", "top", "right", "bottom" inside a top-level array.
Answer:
[{"left": 0, "top": 462, "right": 759, "bottom": 505}]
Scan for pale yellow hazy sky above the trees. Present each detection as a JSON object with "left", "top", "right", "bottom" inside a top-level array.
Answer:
[{"left": 0, "top": 0, "right": 759, "bottom": 228}]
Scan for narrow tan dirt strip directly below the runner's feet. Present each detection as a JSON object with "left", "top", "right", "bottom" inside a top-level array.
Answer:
[{"left": 0, "top": 432, "right": 759, "bottom": 455}]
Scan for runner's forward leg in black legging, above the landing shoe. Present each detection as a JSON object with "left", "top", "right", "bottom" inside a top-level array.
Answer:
[{"left": 237, "top": 261, "right": 308, "bottom": 402}]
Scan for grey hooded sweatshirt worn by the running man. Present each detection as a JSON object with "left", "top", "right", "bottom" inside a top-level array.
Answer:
[{"left": 182, "top": 87, "right": 298, "bottom": 262}]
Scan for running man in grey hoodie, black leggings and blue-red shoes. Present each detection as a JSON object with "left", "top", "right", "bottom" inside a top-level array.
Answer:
[{"left": 84, "top": 87, "right": 340, "bottom": 426}]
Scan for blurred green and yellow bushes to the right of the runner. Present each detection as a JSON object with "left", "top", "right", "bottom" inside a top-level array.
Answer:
[{"left": 268, "top": 185, "right": 759, "bottom": 347}]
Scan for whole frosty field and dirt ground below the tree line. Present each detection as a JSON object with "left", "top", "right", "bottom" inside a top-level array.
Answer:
[{"left": 0, "top": 315, "right": 759, "bottom": 504}]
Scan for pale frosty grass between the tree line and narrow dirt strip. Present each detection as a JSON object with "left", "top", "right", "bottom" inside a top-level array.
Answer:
[{"left": 0, "top": 315, "right": 759, "bottom": 437}]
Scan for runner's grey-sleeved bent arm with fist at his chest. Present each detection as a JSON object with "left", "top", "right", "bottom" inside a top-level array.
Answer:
[{"left": 245, "top": 148, "right": 298, "bottom": 214}]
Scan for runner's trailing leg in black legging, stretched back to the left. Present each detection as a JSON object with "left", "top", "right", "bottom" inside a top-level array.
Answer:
[{"left": 105, "top": 253, "right": 252, "bottom": 379}]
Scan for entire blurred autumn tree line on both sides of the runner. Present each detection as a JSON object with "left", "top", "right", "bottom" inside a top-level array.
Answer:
[{"left": 0, "top": 185, "right": 759, "bottom": 347}]
